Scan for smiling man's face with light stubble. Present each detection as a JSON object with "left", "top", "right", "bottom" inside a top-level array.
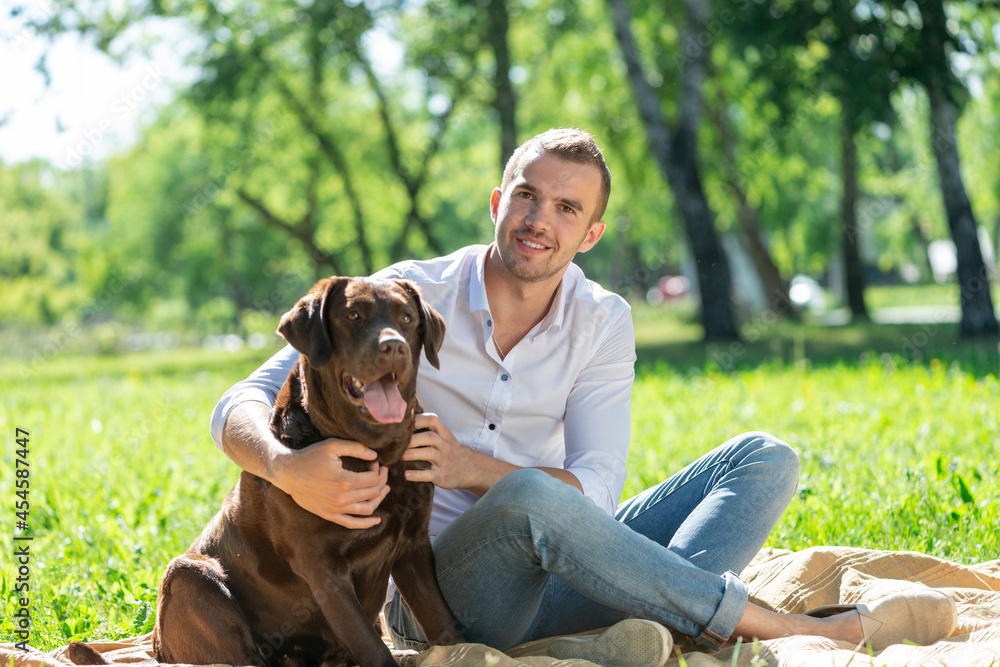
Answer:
[{"left": 490, "top": 154, "right": 605, "bottom": 282}]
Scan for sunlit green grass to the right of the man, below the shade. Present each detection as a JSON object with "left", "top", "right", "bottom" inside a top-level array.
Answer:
[{"left": 625, "top": 361, "right": 1000, "bottom": 562}]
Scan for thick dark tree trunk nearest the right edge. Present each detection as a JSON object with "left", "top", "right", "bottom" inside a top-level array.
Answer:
[{"left": 919, "top": 0, "right": 1000, "bottom": 338}]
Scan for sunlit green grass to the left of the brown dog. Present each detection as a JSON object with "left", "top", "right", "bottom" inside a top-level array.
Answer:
[{"left": 0, "top": 350, "right": 274, "bottom": 648}]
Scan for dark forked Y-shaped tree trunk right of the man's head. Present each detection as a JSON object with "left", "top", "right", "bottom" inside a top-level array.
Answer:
[{"left": 608, "top": 0, "right": 739, "bottom": 340}]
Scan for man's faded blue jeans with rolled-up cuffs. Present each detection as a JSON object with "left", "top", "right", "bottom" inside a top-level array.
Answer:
[{"left": 386, "top": 433, "right": 799, "bottom": 650}]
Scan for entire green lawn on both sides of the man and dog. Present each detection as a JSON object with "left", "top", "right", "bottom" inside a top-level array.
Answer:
[{"left": 0, "top": 308, "right": 1000, "bottom": 648}]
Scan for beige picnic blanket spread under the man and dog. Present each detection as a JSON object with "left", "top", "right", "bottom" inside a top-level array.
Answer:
[{"left": 0, "top": 547, "right": 1000, "bottom": 667}]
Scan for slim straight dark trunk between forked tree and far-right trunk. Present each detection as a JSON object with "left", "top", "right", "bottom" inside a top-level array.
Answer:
[{"left": 840, "top": 102, "right": 871, "bottom": 320}]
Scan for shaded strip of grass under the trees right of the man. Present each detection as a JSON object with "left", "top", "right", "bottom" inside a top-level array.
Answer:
[{"left": 636, "top": 311, "right": 1000, "bottom": 377}]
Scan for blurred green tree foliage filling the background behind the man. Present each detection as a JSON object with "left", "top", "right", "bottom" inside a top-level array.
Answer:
[{"left": 0, "top": 0, "right": 1000, "bottom": 340}]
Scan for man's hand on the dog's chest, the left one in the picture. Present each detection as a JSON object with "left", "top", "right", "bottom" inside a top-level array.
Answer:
[{"left": 271, "top": 438, "right": 389, "bottom": 528}]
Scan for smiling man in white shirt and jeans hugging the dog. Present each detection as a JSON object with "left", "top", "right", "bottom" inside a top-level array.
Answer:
[{"left": 212, "top": 130, "right": 884, "bottom": 664}]
